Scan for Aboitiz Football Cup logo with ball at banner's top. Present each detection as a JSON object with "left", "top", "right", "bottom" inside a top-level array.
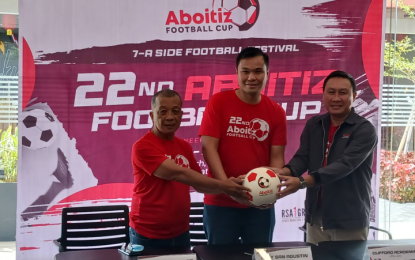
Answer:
[{"left": 166, "top": 0, "right": 259, "bottom": 33}]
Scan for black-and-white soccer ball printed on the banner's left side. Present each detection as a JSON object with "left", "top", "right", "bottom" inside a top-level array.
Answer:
[{"left": 21, "top": 109, "right": 58, "bottom": 150}]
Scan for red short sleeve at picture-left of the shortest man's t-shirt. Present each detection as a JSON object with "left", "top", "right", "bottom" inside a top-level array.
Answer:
[{"left": 132, "top": 140, "right": 169, "bottom": 175}]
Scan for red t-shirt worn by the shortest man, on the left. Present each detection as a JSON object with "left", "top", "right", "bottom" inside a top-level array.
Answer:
[{"left": 130, "top": 131, "right": 201, "bottom": 239}]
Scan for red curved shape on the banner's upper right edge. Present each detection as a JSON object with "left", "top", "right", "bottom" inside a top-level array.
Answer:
[{"left": 362, "top": 0, "right": 383, "bottom": 98}]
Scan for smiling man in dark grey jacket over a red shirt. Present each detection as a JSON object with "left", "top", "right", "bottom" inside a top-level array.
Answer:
[{"left": 276, "top": 71, "right": 378, "bottom": 244}]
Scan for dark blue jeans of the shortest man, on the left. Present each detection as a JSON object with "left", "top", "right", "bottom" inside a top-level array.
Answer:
[{"left": 130, "top": 227, "right": 190, "bottom": 248}]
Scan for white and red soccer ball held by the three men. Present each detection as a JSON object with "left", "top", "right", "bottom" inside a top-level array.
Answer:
[{"left": 242, "top": 167, "right": 280, "bottom": 206}]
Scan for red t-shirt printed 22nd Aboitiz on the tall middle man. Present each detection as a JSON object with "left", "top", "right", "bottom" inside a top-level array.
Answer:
[{"left": 199, "top": 90, "right": 287, "bottom": 208}]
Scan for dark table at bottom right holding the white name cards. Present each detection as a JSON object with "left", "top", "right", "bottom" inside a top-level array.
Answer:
[{"left": 193, "top": 239, "right": 415, "bottom": 260}]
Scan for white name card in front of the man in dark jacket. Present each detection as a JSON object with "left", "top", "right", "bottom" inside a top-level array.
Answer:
[{"left": 367, "top": 245, "right": 415, "bottom": 260}]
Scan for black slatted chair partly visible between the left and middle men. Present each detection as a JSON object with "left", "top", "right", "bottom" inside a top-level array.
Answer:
[{"left": 189, "top": 202, "right": 207, "bottom": 247}]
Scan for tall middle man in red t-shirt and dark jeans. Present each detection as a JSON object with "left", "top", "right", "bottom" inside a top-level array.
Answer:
[{"left": 199, "top": 47, "right": 287, "bottom": 244}]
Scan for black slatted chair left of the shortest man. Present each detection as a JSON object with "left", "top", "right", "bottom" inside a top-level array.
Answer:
[{"left": 53, "top": 205, "right": 130, "bottom": 252}]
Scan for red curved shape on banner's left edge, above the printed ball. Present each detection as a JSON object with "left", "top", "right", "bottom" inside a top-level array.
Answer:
[{"left": 22, "top": 37, "right": 36, "bottom": 111}]
